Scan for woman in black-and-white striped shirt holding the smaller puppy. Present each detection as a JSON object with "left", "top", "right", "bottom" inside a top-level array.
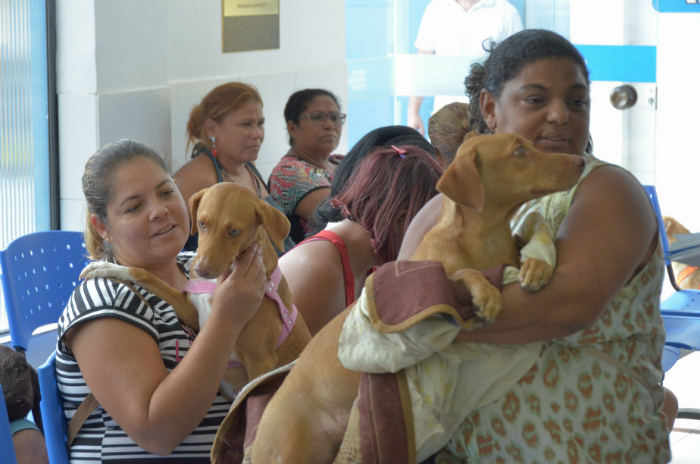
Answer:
[{"left": 56, "top": 140, "right": 266, "bottom": 463}]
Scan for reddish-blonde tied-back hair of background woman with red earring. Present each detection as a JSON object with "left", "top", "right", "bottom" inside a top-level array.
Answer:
[{"left": 187, "top": 82, "right": 262, "bottom": 150}]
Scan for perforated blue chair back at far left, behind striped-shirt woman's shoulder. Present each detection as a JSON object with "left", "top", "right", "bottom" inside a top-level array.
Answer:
[{"left": 0, "top": 230, "right": 89, "bottom": 351}]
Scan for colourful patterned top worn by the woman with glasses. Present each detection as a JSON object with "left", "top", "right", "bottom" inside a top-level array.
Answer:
[{"left": 267, "top": 152, "right": 344, "bottom": 243}]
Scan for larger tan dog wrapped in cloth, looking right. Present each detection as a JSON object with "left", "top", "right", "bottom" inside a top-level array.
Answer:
[{"left": 253, "top": 134, "right": 585, "bottom": 464}]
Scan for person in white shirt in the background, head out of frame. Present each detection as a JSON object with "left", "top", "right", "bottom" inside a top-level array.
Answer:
[{"left": 408, "top": 0, "right": 523, "bottom": 134}]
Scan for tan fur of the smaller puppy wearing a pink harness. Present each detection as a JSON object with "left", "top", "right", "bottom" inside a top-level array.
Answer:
[{"left": 190, "top": 182, "right": 311, "bottom": 391}]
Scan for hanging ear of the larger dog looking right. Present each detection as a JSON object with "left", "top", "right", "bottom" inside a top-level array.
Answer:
[{"left": 437, "top": 141, "right": 486, "bottom": 211}]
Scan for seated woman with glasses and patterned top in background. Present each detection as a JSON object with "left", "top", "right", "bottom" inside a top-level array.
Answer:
[{"left": 267, "top": 89, "right": 345, "bottom": 243}]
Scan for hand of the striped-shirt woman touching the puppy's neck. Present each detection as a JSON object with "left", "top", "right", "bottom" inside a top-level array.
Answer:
[{"left": 212, "top": 244, "right": 267, "bottom": 328}]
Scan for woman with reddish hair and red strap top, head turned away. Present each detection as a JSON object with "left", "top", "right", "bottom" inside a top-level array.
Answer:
[{"left": 279, "top": 126, "right": 442, "bottom": 335}]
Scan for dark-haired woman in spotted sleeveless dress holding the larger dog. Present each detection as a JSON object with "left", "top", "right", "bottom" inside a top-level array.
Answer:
[{"left": 400, "top": 30, "right": 670, "bottom": 464}]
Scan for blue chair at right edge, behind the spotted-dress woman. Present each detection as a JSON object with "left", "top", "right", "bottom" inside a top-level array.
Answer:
[{"left": 644, "top": 185, "right": 700, "bottom": 420}]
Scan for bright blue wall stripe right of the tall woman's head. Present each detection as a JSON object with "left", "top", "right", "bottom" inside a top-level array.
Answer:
[{"left": 576, "top": 45, "right": 656, "bottom": 82}]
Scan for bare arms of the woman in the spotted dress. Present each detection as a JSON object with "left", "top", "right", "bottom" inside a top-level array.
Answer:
[{"left": 399, "top": 167, "right": 657, "bottom": 344}]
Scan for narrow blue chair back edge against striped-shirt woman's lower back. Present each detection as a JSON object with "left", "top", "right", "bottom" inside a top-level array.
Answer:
[{"left": 38, "top": 351, "right": 70, "bottom": 464}]
